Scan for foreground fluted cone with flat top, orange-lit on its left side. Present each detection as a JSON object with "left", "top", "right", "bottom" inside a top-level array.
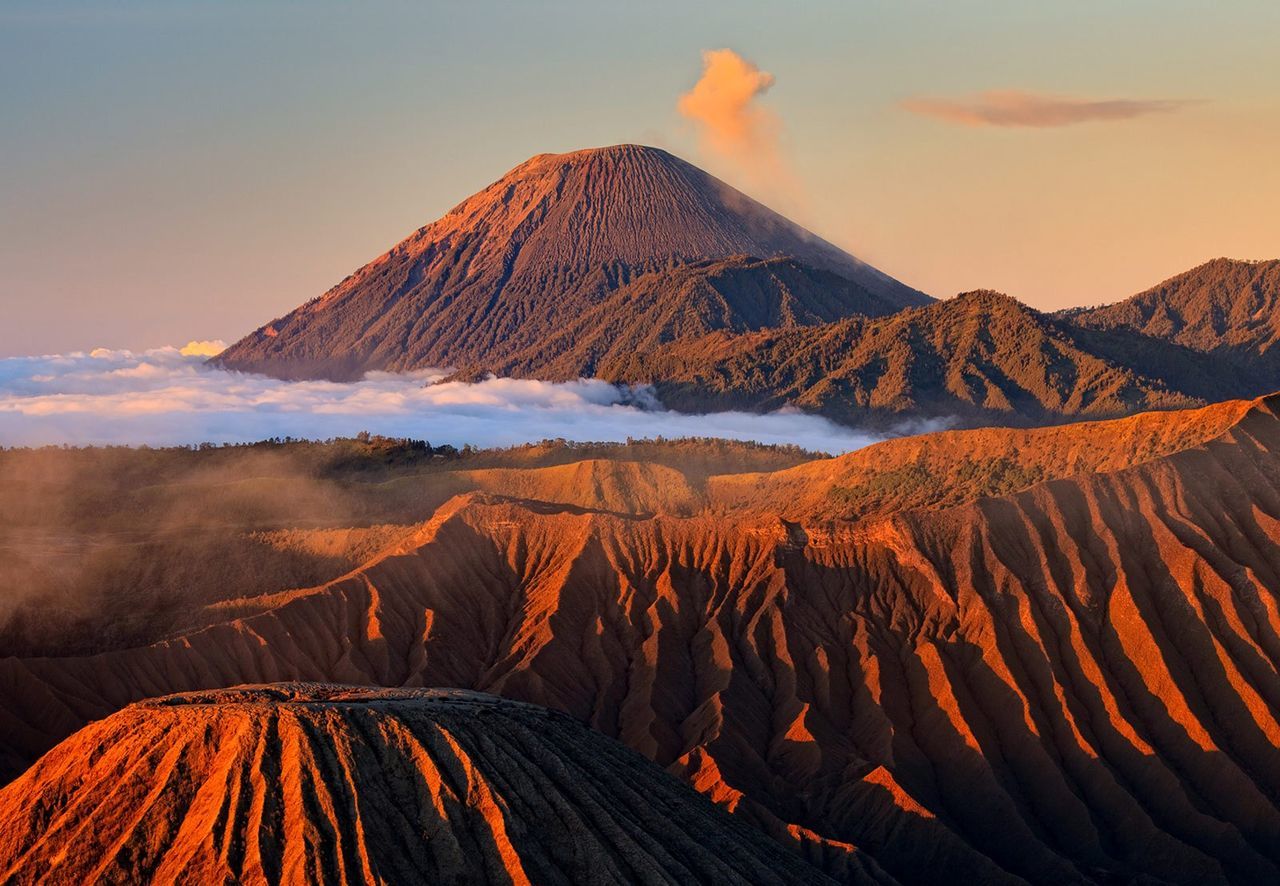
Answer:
[{"left": 0, "top": 684, "right": 844, "bottom": 886}]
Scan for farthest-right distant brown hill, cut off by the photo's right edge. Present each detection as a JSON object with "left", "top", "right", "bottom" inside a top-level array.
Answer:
[{"left": 1065, "top": 259, "right": 1280, "bottom": 371}]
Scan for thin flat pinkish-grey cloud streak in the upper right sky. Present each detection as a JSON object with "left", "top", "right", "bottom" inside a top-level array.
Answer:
[{"left": 901, "top": 90, "right": 1192, "bottom": 128}]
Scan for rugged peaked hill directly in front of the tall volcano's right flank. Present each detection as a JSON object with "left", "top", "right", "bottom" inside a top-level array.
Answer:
[{"left": 609, "top": 285, "right": 1204, "bottom": 423}]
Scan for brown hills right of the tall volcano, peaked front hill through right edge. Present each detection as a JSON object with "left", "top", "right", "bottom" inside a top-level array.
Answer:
[{"left": 586, "top": 260, "right": 1280, "bottom": 425}]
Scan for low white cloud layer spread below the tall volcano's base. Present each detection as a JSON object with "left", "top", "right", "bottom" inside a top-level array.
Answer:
[{"left": 0, "top": 342, "right": 901, "bottom": 453}]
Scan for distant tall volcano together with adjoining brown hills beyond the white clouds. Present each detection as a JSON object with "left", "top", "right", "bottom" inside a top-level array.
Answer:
[{"left": 215, "top": 145, "right": 1280, "bottom": 424}]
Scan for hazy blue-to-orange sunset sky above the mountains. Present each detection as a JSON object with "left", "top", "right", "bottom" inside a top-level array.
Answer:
[{"left": 0, "top": 0, "right": 1280, "bottom": 356}]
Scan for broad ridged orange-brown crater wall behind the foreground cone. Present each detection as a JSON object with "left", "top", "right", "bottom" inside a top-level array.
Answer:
[{"left": 0, "top": 398, "right": 1280, "bottom": 883}]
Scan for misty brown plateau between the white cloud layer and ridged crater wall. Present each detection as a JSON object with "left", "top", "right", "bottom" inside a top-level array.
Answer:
[{"left": 0, "top": 438, "right": 813, "bottom": 656}]
